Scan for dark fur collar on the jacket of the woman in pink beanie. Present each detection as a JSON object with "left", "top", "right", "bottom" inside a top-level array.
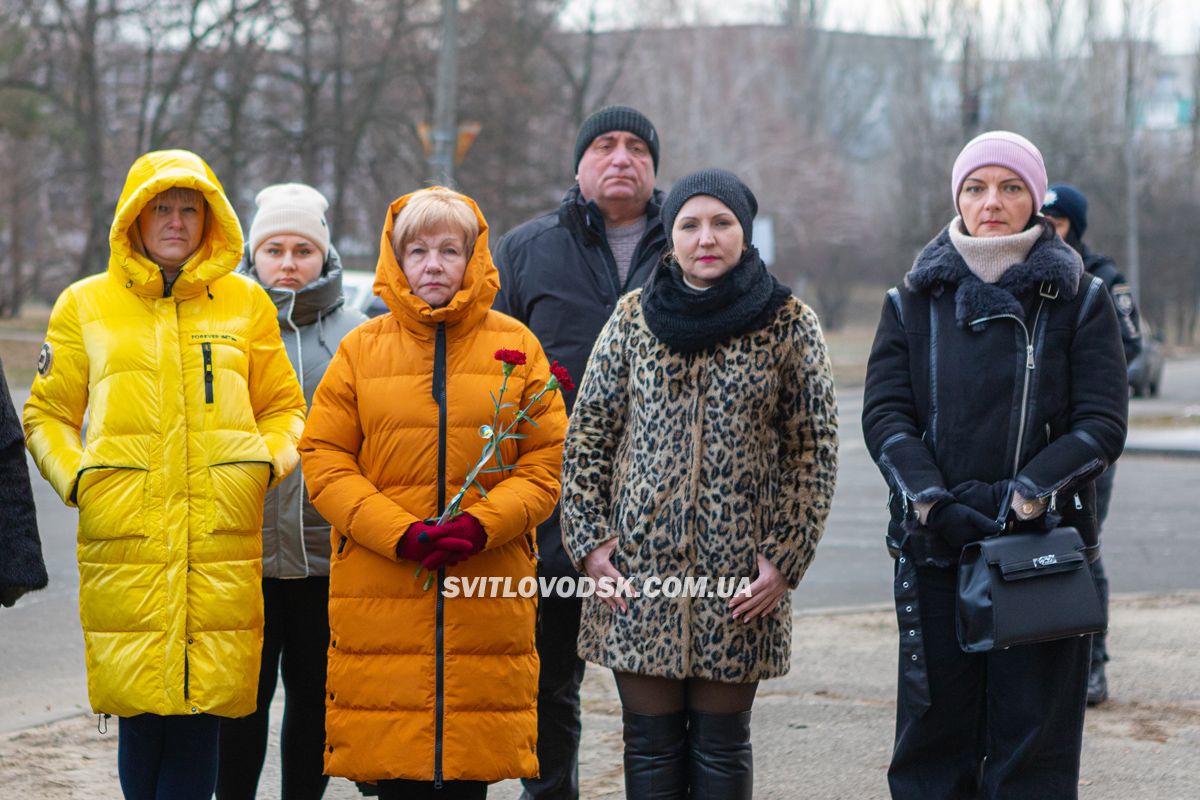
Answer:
[{"left": 905, "top": 221, "right": 1084, "bottom": 326}]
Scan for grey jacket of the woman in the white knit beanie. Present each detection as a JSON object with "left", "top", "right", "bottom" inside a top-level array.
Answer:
[{"left": 239, "top": 247, "right": 366, "bottom": 578}]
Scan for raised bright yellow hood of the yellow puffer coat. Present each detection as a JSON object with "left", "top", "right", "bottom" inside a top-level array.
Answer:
[{"left": 108, "top": 150, "right": 242, "bottom": 299}]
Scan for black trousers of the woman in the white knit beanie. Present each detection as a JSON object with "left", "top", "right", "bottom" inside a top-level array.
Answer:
[{"left": 217, "top": 577, "right": 329, "bottom": 800}]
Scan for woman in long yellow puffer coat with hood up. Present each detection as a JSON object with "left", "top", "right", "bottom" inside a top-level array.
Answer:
[{"left": 24, "top": 150, "right": 305, "bottom": 800}]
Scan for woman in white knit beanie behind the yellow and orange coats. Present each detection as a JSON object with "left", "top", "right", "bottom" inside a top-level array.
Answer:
[{"left": 217, "top": 184, "right": 366, "bottom": 800}]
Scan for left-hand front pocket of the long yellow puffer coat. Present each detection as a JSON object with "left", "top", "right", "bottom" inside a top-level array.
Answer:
[{"left": 76, "top": 467, "right": 150, "bottom": 541}]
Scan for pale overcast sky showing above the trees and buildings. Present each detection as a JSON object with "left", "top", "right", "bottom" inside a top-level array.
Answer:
[{"left": 566, "top": 0, "right": 1200, "bottom": 53}]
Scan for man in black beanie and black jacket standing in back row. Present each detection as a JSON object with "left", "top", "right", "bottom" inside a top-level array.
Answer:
[{"left": 493, "top": 106, "right": 667, "bottom": 800}]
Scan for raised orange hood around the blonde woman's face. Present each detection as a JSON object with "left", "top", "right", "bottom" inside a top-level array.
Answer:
[{"left": 373, "top": 192, "right": 500, "bottom": 338}]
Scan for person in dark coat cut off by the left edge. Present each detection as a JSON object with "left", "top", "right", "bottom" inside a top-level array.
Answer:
[{"left": 0, "top": 355, "right": 47, "bottom": 606}]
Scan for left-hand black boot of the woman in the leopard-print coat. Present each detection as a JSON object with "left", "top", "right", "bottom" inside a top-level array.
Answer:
[{"left": 622, "top": 711, "right": 688, "bottom": 800}]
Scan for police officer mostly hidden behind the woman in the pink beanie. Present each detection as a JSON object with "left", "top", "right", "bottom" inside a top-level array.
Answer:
[{"left": 1042, "top": 184, "right": 1141, "bottom": 705}]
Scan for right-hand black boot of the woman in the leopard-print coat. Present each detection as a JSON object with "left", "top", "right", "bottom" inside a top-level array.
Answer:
[{"left": 688, "top": 711, "right": 754, "bottom": 800}]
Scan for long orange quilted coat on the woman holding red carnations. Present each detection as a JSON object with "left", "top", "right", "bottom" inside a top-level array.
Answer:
[{"left": 300, "top": 189, "right": 566, "bottom": 781}]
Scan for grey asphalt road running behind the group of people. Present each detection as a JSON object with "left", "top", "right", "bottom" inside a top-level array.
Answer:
[{"left": 0, "top": 360, "right": 1200, "bottom": 733}]
